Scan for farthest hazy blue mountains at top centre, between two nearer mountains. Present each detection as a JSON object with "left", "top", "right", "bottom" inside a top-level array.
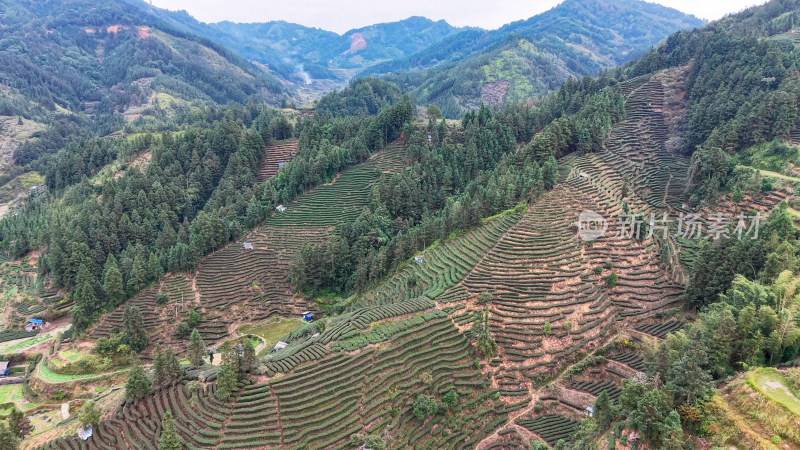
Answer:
[{"left": 131, "top": 0, "right": 463, "bottom": 97}]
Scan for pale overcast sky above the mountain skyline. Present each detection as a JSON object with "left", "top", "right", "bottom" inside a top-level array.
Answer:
[{"left": 151, "top": 0, "right": 764, "bottom": 34}]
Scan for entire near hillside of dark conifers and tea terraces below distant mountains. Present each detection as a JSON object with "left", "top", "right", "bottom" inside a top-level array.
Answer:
[{"left": 7, "top": 0, "right": 800, "bottom": 450}]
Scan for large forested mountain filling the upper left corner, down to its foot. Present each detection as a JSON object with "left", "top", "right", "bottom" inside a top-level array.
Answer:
[{"left": 0, "top": 0, "right": 295, "bottom": 169}]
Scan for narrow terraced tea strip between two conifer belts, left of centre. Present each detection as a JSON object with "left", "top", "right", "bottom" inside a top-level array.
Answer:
[{"left": 196, "top": 143, "right": 405, "bottom": 319}]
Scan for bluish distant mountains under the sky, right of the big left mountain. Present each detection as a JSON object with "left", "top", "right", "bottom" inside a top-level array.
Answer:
[{"left": 126, "top": 0, "right": 705, "bottom": 108}]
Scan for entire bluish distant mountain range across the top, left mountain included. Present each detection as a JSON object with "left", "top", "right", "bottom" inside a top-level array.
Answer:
[{"left": 0, "top": 0, "right": 703, "bottom": 119}]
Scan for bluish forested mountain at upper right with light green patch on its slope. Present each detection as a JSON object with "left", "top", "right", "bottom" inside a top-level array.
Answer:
[{"left": 372, "top": 0, "right": 704, "bottom": 117}]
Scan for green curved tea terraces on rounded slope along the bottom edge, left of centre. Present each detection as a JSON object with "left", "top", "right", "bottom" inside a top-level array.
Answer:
[{"left": 40, "top": 303, "right": 507, "bottom": 449}]
